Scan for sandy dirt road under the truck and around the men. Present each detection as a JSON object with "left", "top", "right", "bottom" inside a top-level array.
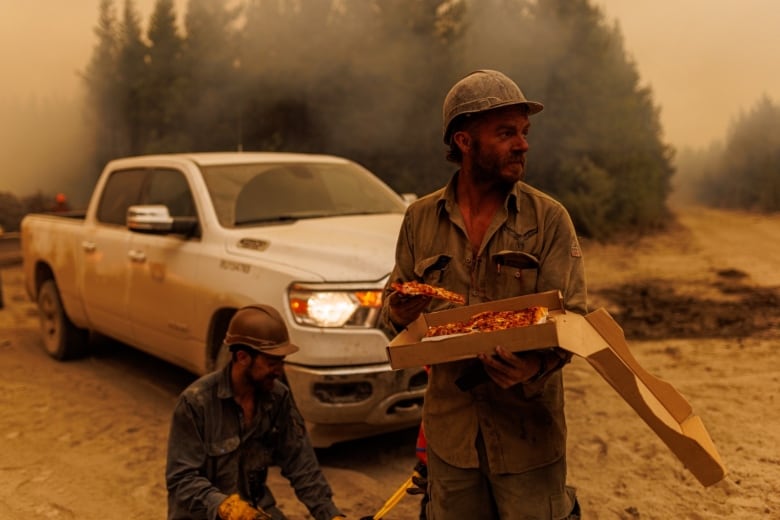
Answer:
[{"left": 0, "top": 205, "right": 780, "bottom": 520}]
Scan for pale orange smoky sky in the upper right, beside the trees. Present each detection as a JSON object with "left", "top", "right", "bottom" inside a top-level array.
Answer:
[{"left": 594, "top": 0, "right": 780, "bottom": 148}]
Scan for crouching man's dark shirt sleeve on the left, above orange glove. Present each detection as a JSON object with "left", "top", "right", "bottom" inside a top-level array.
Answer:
[{"left": 165, "top": 397, "right": 227, "bottom": 520}]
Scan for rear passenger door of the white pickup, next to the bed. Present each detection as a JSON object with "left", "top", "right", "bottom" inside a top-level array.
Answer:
[{"left": 81, "top": 170, "right": 143, "bottom": 343}]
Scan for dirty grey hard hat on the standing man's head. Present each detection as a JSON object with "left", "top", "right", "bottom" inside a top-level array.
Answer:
[{"left": 442, "top": 69, "right": 544, "bottom": 144}]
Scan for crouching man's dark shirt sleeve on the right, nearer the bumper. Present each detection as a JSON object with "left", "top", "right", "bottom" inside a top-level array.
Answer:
[{"left": 276, "top": 396, "right": 343, "bottom": 520}]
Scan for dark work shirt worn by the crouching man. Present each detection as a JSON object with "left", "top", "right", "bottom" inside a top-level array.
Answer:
[{"left": 165, "top": 362, "right": 341, "bottom": 520}]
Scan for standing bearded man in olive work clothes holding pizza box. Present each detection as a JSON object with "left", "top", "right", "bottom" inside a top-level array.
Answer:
[{"left": 381, "top": 70, "right": 587, "bottom": 520}]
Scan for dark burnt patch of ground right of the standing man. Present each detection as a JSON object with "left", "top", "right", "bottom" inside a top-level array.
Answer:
[{"left": 596, "top": 269, "right": 780, "bottom": 340}]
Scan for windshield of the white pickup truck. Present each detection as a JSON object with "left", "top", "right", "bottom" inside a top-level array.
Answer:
[{"left": 201, "top": 162, "right": 406, "bottom": 228}]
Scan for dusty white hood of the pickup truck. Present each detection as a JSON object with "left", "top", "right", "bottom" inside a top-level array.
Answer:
[{"left": 226, "top": 214, "right": 403, "bottom": 282}]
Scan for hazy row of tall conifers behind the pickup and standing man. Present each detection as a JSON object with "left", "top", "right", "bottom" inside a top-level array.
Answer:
[{"left": 4, "top": 0, "right": 673, "bottom": 238}]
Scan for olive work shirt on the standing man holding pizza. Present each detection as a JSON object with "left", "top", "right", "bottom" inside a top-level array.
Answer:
[{"left": 380, "top": 173, "right": 587, "bottom": 473}]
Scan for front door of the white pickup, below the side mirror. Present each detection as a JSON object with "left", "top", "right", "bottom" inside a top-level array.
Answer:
[{"left": 128, "top": 169, "right": 206, "bottom": 370}]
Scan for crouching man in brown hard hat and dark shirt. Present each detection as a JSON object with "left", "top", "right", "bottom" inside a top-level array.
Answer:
[{"left": 165, "top": 305, "right": 344, "bottom": 520}]
